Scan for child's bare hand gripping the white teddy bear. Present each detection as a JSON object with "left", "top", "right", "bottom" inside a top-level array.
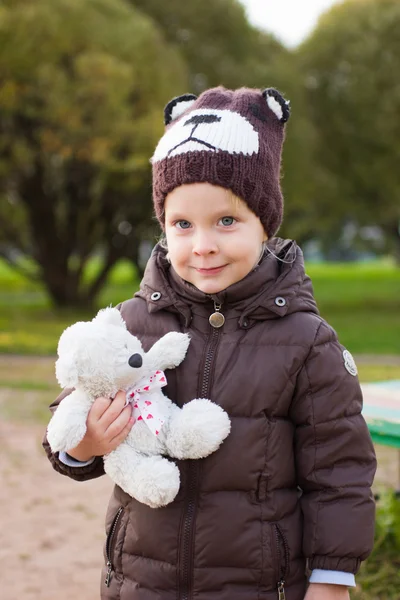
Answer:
[{"left": 68, "top": 391, "right": 134, "bottom": 462}]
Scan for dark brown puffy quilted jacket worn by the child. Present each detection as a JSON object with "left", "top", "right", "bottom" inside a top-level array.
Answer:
[{"left": 44, "top": 239, "right": 375, "bottom": 600}]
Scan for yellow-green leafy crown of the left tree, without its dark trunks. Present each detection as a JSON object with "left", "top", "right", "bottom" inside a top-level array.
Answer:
[{"left": 0, "top": 0, "right": 183, "bottom": 171}]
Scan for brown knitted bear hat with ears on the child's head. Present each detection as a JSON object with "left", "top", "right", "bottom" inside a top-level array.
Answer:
[{"left": 151, "top": 87, "right": 290, "bottom": 238}]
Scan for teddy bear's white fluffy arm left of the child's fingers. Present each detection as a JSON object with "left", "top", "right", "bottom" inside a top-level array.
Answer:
[{"left": 47, "top": 390, "right": 93, "bottom": 452}]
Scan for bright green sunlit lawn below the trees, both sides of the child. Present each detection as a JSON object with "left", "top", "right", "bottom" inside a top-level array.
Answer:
[{"left": 0, "top": 260, "right": 400, "bottom": 354}]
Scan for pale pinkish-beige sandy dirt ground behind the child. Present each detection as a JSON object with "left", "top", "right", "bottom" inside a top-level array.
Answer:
[{"left": 0, "top": 357, "right": 399, "bottom": 600}]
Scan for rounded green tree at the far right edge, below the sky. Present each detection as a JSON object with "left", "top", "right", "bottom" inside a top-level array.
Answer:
[{"left": 299, "top": 0, "right": 400, "bottom": 261}]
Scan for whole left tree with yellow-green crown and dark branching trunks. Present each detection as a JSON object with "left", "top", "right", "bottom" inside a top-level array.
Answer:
[{"left": 0, "top": 0, "right": 187, "bottom": 307}]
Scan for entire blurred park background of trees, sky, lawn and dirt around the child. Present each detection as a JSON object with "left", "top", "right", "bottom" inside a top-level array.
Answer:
[{"left": 0, "top": 0, "right": 400, "bottom": 600}]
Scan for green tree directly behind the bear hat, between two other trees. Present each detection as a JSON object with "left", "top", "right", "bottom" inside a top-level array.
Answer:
[{"left": 130, "top": 0, "right": 315, "bottom": 241}]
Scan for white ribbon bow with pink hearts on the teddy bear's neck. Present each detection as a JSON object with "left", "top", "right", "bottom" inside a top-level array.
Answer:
[{"left": 126, "top": 371, "right": 167, "bottom": 435}]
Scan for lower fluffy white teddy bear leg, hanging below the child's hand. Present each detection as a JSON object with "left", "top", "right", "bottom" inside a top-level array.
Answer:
[{"left": 104, "top": 443, "right": 180, "bottom": 508}]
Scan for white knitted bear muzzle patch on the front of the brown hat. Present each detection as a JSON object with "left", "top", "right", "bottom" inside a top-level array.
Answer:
[{"left": 151, "top": 108, "right": 259, "bottom": 163}]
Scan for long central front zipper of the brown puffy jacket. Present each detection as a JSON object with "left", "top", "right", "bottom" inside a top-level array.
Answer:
[{"left": 180, "top": 304, "right": 220, "bottom": 600}]
